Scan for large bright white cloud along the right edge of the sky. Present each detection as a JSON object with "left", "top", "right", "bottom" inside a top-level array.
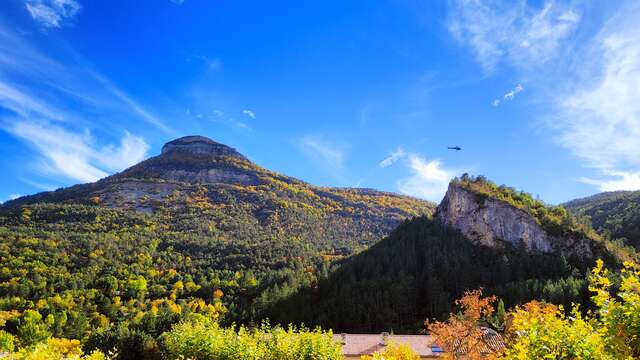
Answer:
[{"left": 553, "top": 3, "right": 640, "bottom": 190}]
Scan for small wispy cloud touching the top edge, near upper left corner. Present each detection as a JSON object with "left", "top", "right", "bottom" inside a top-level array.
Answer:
[{"left": 25, "top": 0, "right": 80, "bottom": 28}]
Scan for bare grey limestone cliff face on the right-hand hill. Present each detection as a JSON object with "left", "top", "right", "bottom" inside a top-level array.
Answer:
[{"left": 436, "top": 182, "right": 592, "bottom": 256}]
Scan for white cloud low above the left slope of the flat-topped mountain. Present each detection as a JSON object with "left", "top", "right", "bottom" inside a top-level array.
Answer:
[{"left": 5, "top": 121, "right": 149, "bottom": 182}]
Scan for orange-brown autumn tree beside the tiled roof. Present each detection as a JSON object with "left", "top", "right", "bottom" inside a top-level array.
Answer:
[{"left": 425, "top": 289, "right": 504, "bottom": 360}]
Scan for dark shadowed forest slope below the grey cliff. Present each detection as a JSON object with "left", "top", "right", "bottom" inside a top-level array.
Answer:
[{"left": 264, "top": 217, "right": 608, "bottom": 332}]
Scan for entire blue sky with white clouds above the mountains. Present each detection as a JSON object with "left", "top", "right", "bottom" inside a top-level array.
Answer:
[{"left": 0, "top": 0, "right": 640, "bottom": 203}]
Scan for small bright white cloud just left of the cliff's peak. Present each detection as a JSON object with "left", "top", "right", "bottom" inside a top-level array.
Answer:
[{"left": 397, "top": 154, "right": 455, "bottom": 202}]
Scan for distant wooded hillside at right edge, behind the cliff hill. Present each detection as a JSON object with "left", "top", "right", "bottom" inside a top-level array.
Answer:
[{"left": 564, "top": 191, "right": 640, "bottom": 249}]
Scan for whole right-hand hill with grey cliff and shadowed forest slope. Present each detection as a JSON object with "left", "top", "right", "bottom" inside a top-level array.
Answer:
[{"left": 264, "top": 177, "right": 635, "bottom": 332}]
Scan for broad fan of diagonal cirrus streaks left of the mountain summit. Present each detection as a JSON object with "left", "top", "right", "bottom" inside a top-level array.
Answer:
[{"left": 0, "top": 25, "right": 162, "bottom": 188}]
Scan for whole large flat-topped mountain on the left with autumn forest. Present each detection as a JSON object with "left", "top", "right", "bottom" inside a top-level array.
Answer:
[{"left": 0, "top": 137, "right": 434, "bottom": 358}]
